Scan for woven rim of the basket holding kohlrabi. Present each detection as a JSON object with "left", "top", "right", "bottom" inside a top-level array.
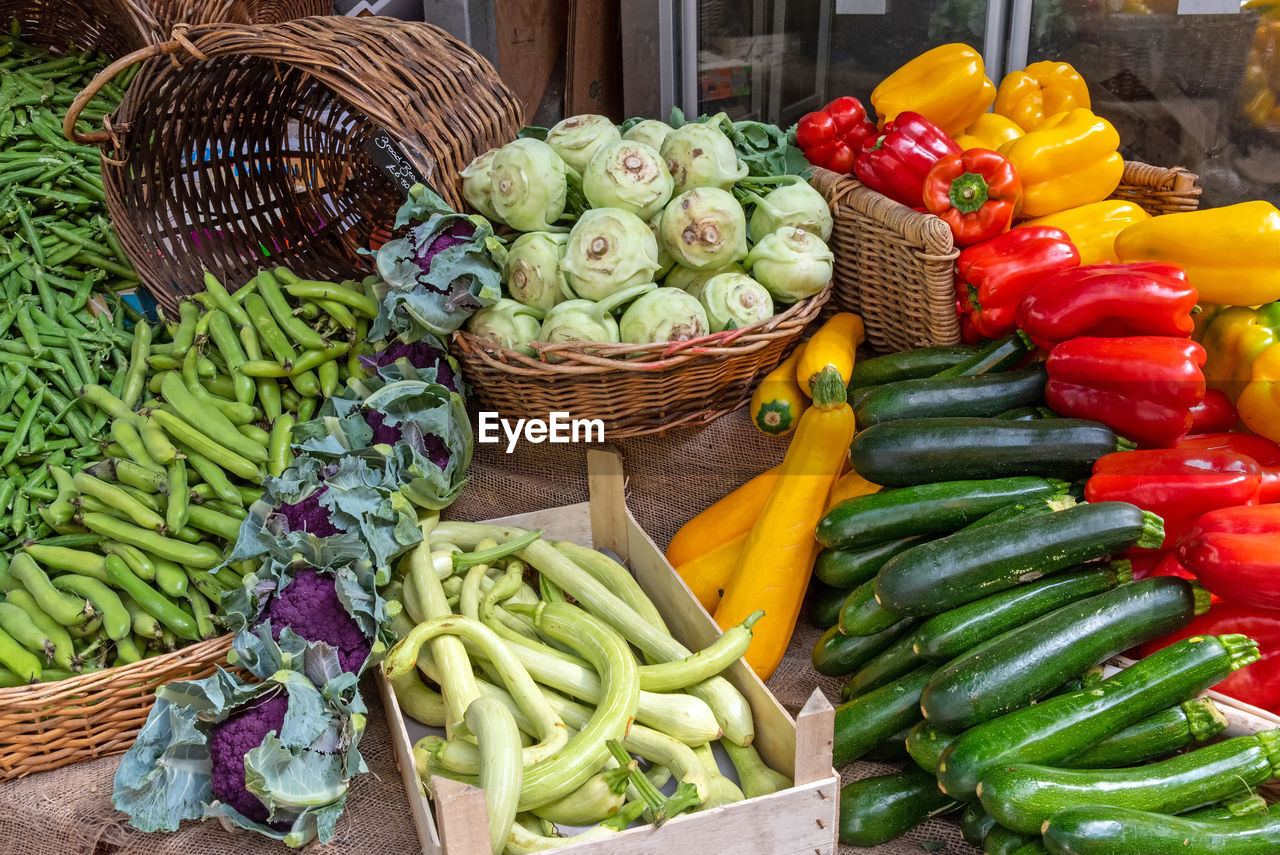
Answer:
[{"left": 453, "top": 280, "right": 835, "bottom": 379}]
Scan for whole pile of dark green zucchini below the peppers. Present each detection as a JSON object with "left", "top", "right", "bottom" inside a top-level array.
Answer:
[{"left": 809, "top": 338, "right": 1280, "bottom": 855}]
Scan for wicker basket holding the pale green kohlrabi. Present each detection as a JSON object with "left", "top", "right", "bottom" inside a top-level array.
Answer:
[{"left": 453, "top": 287, "right": 831, "bottom": 440}]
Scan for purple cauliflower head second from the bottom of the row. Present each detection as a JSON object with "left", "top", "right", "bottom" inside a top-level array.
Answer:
[{"left": 259, "top": 570, "right": 372, "bottom": 673}]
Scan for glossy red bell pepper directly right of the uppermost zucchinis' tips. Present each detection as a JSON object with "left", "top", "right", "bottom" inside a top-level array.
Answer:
[{"left": 1044, "top": 335, "right": 1204, "bottom": 447}]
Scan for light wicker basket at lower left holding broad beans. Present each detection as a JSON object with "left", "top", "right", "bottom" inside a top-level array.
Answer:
[{"left": 0, "top": 635, "right": 232, "bottom": 781}]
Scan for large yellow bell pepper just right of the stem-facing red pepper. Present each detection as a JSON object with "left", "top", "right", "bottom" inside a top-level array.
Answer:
[{"left": 1000, "top": 108, "right": 1124, "bottom": 216}]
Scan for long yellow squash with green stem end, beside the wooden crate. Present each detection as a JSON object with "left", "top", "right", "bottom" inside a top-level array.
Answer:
[{"left": 716, "top": 367, "right": 854, "bottom": 680}]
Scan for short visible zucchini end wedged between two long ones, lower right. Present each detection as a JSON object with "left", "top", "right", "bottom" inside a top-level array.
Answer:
[{"left": 1066, "top": 698, "right": 1226, "bottom": 769}]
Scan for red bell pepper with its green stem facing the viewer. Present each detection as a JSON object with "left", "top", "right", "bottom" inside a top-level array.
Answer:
[{"left": 924, "top": 148, "right": 1023, "bottom": 247}]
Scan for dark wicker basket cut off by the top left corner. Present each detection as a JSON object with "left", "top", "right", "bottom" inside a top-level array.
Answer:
[{"left": 0, "top": 0, "right": 160, "bottom": 59}]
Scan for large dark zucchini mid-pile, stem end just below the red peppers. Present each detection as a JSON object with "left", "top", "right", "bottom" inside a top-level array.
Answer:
[{"left": 876, "top": 496, "right": 1165, "bottom": 616}]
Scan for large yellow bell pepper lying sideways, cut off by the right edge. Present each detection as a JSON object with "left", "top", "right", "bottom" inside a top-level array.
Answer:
[{"left": 1116, "top": 200, "right": 1280, "bottom": 306}]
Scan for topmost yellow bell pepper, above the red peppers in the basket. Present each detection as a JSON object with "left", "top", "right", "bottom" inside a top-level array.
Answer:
[{"left": 872, "top": 44, "right": 996, "bottom": 137}]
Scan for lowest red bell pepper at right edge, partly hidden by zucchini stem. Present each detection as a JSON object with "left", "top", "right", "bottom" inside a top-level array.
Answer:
[{"left": 1142, "top": 603, "right": 1280, "bottom": 713}]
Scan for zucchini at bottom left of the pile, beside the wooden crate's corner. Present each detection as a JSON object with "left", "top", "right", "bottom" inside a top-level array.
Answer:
[{"left": 840, "top": 769, "right": 955, "bottom": 847}]
